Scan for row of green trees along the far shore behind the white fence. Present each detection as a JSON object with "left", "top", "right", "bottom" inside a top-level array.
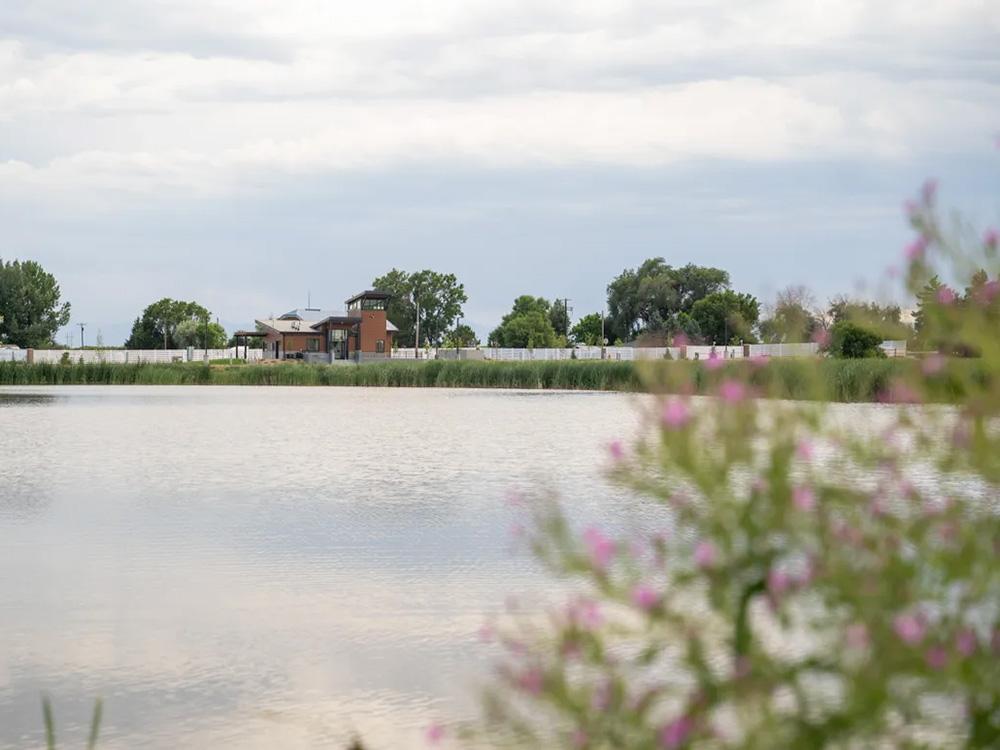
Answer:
[{"left": 0, "top": 257, "right": 1000, "bottom": 355}]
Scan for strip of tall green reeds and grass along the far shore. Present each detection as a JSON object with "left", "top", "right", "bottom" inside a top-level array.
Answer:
[{"left": 0, "top": 359, "right": 986, "bottom": 401}]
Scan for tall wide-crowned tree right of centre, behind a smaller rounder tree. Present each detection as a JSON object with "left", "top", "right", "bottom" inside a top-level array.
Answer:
[{"left": 608, "top": 258, "right": 729, "bottom": 340}]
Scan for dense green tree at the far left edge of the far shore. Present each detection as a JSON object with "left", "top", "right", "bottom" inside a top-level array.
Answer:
[{"left": 0, "top": 259, "right": 70, "bottom": 349}]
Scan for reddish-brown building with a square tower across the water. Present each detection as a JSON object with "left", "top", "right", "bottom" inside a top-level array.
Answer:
[{"left": 254, "top": 290, "right": 399, "bottom": 362}]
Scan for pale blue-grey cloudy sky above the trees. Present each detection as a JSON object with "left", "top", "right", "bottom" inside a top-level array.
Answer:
[{"left": 0, "top": 0, "right": 1000, "bottom": 344}]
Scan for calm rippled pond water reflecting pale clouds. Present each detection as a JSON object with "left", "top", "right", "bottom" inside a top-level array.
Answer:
[{"left": 0, "top": 386, "right": 643, "bottom": 748}]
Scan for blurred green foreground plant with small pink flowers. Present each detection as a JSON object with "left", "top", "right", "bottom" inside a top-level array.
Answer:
[{"left": 484, "top": 184, "right": 1000, "bottom": 748}]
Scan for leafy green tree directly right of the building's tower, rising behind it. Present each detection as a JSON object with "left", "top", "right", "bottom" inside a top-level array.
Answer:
[{"left": 372, "top": 268, "right": 469, "bottom": 347}]
